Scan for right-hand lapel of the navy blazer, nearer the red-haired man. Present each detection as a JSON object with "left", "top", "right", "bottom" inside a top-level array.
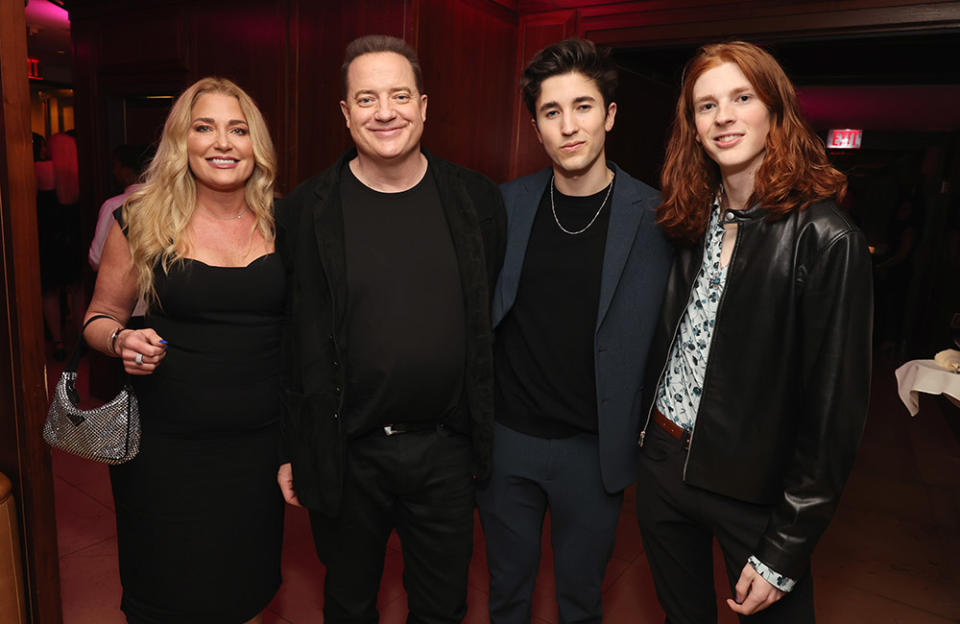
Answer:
[{"left": 597, "top": 165, "right": 648, "bottom": 329}]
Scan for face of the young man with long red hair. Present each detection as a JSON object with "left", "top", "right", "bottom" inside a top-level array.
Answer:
[{"left": 693, "top": 62, "right": 770, "bottom": 177}]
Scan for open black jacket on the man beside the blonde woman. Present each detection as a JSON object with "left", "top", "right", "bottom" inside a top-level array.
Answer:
[{"left": 277, "top": 150, "right": 506, "bottom": 516}]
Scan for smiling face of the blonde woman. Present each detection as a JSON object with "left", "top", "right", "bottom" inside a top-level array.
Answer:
[{"left": 187, "top": 93, "right": 255, "bottom": 192}]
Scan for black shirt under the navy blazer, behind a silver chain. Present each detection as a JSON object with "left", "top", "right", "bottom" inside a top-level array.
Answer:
[{"left": 494, "top": 176, "right": 610, "bottom": 438}]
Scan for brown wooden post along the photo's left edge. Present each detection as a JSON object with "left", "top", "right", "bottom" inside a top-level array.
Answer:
[{"left": 0, "top": 2, "right": 61, "bottom": 624}]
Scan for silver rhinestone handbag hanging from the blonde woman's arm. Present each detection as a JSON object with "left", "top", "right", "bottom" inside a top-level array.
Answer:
[{"left": 43, "top": 315, "right": 140, "bottom": 464}]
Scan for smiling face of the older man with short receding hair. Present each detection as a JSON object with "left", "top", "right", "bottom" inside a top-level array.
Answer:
[{"left": 340, "top": 52, "right": 427, "bottom": 161}]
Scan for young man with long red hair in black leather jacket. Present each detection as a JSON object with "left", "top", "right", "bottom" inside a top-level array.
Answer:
[{"left": 637, "top": 42, "right": 872, "bottom": 624}]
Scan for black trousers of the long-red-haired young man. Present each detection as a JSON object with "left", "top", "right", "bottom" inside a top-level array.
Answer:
[{"left": 637, "top": 424, "right": 814, "bottom": 624}]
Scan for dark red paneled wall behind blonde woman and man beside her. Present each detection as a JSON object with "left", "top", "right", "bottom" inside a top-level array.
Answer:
[{"left": 68, "top": 0, "right": 517, "bottom": 216}]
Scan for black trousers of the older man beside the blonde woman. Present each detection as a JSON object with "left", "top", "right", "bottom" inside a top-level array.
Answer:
[{"left": 310, "top": 428, "right": 475, "bottom": 624}]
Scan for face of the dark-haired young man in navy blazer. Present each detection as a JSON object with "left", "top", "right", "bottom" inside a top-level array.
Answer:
[{"left": 533, "top": 72, "right": 617, "bottom": 176}]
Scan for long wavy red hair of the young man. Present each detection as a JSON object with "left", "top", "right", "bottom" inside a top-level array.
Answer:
[{"left": 657, "top": 41, "right": 847, "bottom": 244}]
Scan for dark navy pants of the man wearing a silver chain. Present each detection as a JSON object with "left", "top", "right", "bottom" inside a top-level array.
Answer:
[{"left": 477, "top": 424, "right": 623, "bottom": 624}]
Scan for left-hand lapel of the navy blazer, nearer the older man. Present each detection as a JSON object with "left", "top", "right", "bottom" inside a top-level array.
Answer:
[{"left": 493, "top": 169, "right": 550, "bottom": 327}]
